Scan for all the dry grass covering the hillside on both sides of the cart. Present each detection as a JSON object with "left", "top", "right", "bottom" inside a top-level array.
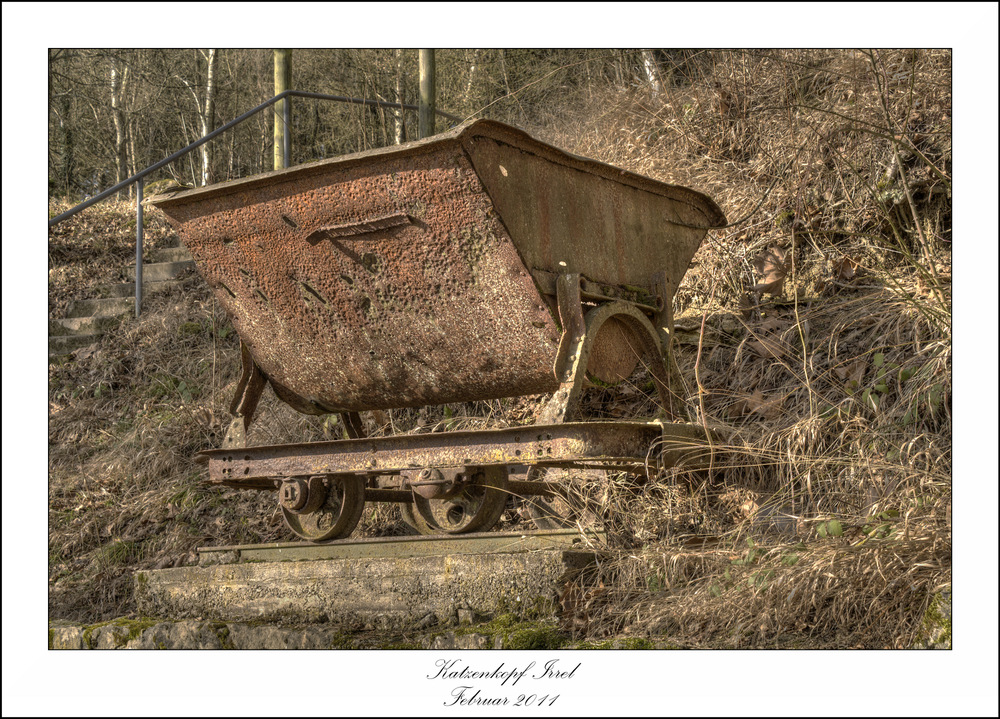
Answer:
[{"left": 50, "top": 51, "right": 952, "bottom": 647}]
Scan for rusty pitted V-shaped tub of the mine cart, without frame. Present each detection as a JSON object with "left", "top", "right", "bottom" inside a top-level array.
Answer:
[{"left": 153, "top": 120, "right": 725, "bottom": 414}]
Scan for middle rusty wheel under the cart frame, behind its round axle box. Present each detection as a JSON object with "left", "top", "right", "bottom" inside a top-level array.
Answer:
[{"left": 413, "top": 466, "right": 508, "bottom": 534}]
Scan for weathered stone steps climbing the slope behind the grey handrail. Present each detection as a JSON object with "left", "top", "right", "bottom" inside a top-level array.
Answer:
[{"left": 49, "top": 245, "right": 194, "bottom": 361}]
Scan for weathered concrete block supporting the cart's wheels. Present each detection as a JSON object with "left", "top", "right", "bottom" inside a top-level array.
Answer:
[{"left": 135, "top": 531, "right": 597, "bottom": 629}]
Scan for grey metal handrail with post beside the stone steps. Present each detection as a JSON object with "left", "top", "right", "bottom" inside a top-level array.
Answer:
[{"left": 49, "top": 90, "right": 462, "bottom": 317}]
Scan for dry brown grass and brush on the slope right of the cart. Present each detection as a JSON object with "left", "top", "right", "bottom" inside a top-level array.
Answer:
[{"left": 528, "top": 51, "right": 951, "bottom": 647}]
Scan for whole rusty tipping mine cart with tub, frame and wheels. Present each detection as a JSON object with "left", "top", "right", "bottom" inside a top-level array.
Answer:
[{"left": 154, "top": 120, "right": 725, "bottom": 542}]
